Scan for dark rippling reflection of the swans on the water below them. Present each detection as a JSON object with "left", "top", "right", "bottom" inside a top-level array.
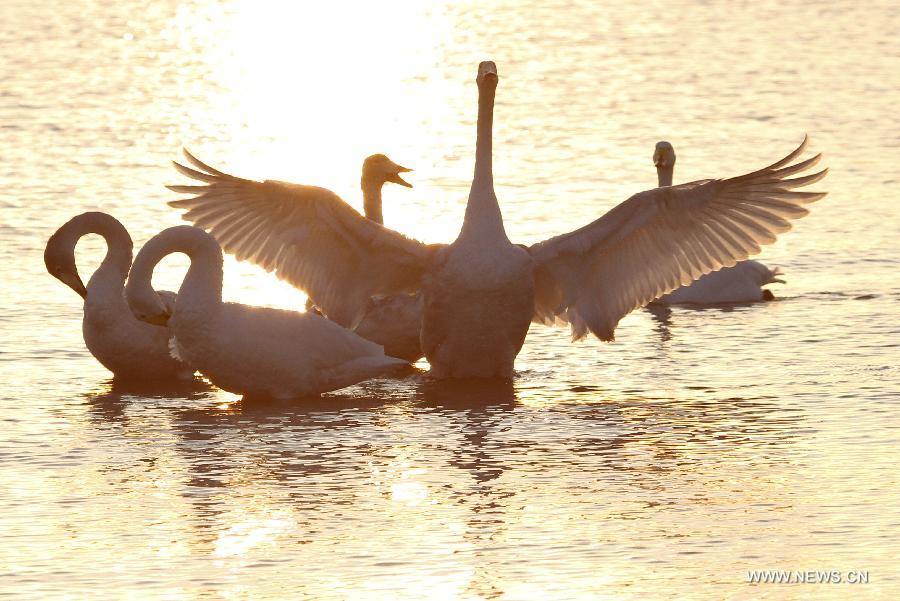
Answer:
[{"left": 81, "top": 374, "right": 804, "bottom": 596}]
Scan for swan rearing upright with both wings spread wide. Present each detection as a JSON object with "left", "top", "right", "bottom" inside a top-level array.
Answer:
[{"left": 165, "top": 61, "right": 828, "bottom": 378}]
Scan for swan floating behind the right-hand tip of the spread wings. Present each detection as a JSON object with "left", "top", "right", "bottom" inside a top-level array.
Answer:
[{"left": 653, "top": 140, "right": 784, "bottom": 305}]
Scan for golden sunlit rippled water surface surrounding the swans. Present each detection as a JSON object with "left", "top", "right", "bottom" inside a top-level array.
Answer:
[{"left": 0, "top": 0, "right": 900, "bottom": 599}]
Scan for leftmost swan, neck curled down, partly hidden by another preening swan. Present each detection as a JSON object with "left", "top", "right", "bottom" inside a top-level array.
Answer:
[{"left": 44, "top": 212, "right": 194, "bottom": 380}]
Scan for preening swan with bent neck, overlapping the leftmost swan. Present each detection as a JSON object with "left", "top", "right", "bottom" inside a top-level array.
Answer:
[{"left": 125, "top": 225, "right": 407, "bottom": 399}]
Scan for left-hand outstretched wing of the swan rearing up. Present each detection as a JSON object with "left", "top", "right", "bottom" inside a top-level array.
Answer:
[{"left": 168, "top": 150, "right": 434, "bottom": 327}]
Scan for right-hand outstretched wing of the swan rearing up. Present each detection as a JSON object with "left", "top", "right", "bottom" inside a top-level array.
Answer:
[{"left": 529, "top": 138, "right": 828, "bottom": 340}]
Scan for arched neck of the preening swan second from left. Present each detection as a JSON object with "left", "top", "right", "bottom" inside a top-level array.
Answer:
[{"left": 128, "top": 225, "right": 222, "bottom": 321}]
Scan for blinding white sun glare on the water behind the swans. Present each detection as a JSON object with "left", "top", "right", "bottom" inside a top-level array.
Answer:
[{"left": 161, "top": 1, "right": 474, "bottom": 308}]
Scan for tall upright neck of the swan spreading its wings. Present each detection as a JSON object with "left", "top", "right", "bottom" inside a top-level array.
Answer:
[{"left": 460, "top": 81, "right": 508, "bottom": 241}]
